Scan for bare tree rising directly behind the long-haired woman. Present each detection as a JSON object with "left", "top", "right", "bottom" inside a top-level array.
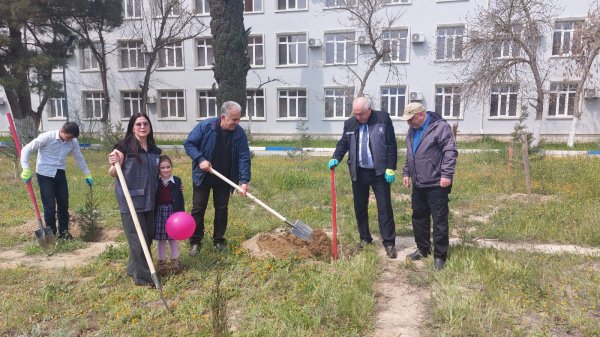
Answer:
[{"left": 126, "top": 0, "right": 208, "bottom": 113}]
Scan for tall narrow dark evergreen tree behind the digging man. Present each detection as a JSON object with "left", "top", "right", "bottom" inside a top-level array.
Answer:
[{"left": 208, "top": 0, "right": 250, "bottom": 115}]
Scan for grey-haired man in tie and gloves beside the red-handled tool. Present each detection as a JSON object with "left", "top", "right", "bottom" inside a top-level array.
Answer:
[{"left": 328, "top": 97, "right": 398, "bottom": 259}]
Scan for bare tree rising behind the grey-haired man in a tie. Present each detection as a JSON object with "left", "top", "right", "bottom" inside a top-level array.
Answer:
[{"left": 325, "top": 0, "right": 406, "bottom": 96}]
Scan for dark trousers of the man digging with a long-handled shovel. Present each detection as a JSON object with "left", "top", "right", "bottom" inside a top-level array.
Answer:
[{"left": 190, "top": 179, "right": 231, "bottom": 244}]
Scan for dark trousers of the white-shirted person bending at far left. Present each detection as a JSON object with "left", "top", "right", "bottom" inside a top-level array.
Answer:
[{"left": 37, "top": 170, "right": 69, "bottom": 234}]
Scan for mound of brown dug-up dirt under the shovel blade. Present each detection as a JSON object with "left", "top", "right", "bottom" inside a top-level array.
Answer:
[{"left": 242, "top": 229, "right": 331, "bottom": 262}]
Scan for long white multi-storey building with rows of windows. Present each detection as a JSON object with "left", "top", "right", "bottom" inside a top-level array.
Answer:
[{"left": 0, "top": 0, "right": 600, "bottom": 139}]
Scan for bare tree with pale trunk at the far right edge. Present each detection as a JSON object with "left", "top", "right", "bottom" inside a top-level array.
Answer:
[{"left": 566, "top": 1, "right": 600, "bottom": 147}]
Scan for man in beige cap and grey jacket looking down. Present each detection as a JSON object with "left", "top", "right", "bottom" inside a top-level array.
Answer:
[{"left": 402, "top": 103, "right": 458, "bottom": 270}]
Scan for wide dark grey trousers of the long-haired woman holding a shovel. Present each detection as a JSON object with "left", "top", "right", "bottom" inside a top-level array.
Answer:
[{"left": 121, "top": 210, "right": 156, "bottom": 284}]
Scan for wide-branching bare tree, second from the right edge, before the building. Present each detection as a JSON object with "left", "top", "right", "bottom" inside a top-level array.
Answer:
[{"left": 459, "top": 0, "right": 556, "bottom": 146}]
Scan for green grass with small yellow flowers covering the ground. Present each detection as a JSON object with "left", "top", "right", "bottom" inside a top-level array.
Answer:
[{"left": 0, "top": 151, "right": 600, "bottom": 336}]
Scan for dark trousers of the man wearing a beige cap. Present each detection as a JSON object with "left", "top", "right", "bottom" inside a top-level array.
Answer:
[{"left": 412, "top": 186, "right": 452, "bottom": 260}]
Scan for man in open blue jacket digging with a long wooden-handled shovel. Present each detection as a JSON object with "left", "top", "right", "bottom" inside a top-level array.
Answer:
[{"left": 183, "top": 101, "right": 250, "bottom": 256}]
